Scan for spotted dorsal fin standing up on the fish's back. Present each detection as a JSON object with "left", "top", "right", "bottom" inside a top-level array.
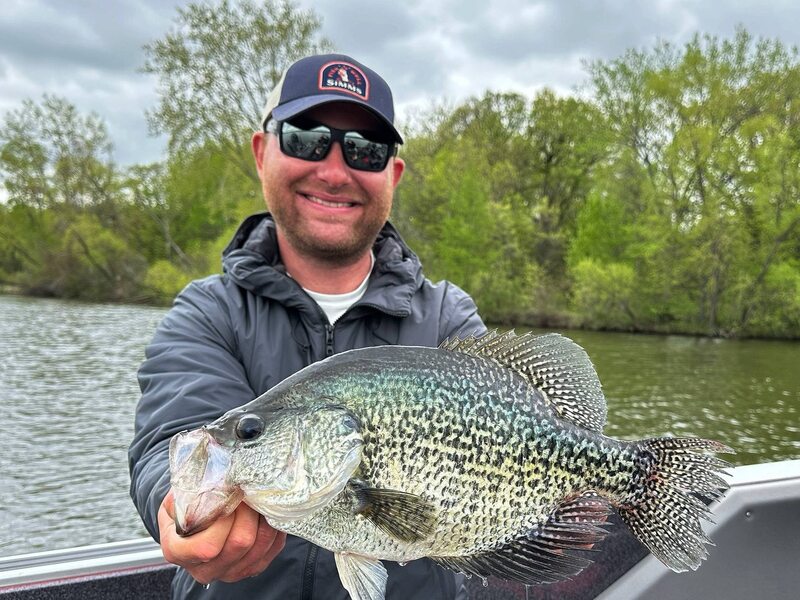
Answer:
[{"left": 439, "top": 330, "right": 607, "bottom": 432}]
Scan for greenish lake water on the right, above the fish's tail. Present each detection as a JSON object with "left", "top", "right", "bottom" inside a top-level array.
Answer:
[{"left": 552, "top": 331, "right": 800, "bottom": 465}]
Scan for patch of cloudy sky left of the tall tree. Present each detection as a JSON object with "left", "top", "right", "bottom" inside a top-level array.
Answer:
[{"left": 0, "top": 0, "right": 181, "bottom": 164}]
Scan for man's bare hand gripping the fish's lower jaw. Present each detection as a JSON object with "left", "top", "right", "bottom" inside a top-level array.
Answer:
[{"left": 158, "top": 491, "right": 286, "bottom": 584}]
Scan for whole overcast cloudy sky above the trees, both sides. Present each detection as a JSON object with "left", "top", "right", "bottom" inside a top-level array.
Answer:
[{"left": 0, "top": 0, "right": 800, "bottom": 165}]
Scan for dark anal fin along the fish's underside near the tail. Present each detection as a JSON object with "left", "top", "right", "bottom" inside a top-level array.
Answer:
[{"left": 430, "top": 494, "right": 610, "bottom": 585}]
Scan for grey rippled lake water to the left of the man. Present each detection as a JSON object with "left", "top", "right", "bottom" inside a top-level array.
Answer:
[{"left": 0, "top": 296, "right": 164, "bottom": 556}]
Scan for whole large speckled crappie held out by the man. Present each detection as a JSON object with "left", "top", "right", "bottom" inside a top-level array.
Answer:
[{"left": 170, "top": 332, "right": 732, "bottom": 600}]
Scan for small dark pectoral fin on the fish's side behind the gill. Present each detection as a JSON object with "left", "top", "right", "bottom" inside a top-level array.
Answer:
[{"left": 347, "top": 479, "right": 436, "bottom": 543}]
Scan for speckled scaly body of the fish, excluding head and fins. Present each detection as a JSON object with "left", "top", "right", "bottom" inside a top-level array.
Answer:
[{"left": 260, "top": 346, "right": 633, "bottom": 561}]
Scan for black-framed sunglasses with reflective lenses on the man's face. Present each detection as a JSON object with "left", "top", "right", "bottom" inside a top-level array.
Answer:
[{"left": 264, "top": 119, "right": 397, "bottom": 171}]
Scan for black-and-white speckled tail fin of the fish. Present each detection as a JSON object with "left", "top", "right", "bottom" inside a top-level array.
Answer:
[{"left": 618, "top": 438, "right": 733, "bottom": 572}]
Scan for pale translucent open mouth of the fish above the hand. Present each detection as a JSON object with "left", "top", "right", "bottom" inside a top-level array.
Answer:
[{"left": 169, "top": 428, "right": 244, "bottom": 536}]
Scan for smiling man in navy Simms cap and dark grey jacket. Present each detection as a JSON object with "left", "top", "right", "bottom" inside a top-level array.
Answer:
[{"left": 129, "top": 55, "right": 485, "bottom": 600}]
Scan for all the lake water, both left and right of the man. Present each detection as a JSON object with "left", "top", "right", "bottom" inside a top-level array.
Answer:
[{"left": 0, "top": 296, "right": 800, "bottom": 556}]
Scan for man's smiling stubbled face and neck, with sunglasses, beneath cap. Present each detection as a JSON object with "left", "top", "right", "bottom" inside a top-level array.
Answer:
[{"left": 253, "top": 101, "right": 405, "bottom": 293}]
